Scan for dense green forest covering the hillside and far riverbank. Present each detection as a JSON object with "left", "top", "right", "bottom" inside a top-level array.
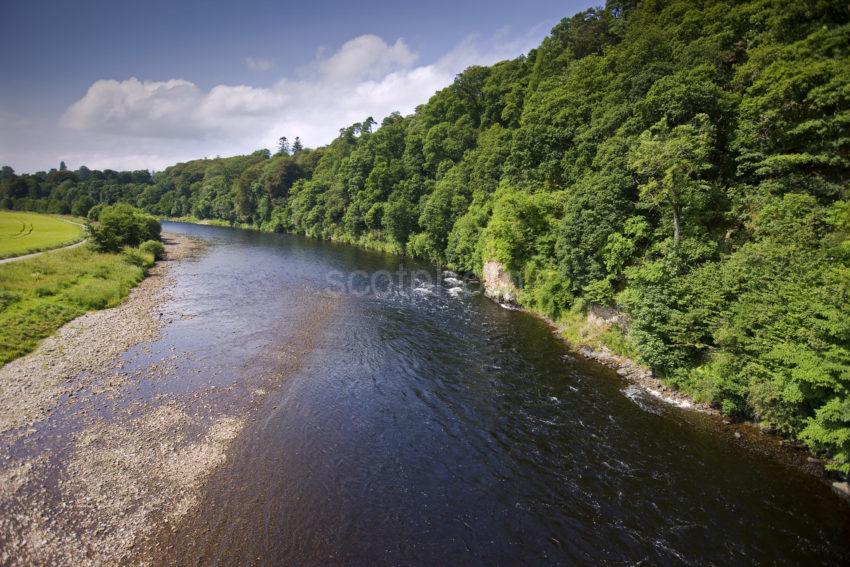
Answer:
[{"left": 0, "top": 0, "right": 850, "bottom": 474}]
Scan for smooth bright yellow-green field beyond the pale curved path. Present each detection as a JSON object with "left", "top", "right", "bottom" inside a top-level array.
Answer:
[{"left": 0, "top": 211, "right": 85, "bottom": 259}]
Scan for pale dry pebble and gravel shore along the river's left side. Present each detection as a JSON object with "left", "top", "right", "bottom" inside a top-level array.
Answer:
[{"left": 0, "top": 234, "right": 248, "bottom": 565}]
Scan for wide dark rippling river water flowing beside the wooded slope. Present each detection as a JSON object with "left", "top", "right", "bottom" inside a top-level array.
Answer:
[{"left": 150, "top": 223, "right": 850, "bottom": 565}]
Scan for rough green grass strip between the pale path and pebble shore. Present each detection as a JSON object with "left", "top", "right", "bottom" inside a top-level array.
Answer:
[{"left": 0, "top": 246, "right": 153, "bottom": 365}]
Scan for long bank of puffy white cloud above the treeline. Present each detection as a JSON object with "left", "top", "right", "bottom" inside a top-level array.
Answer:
[{"left": 48, "top": 30, "right": 543, "bottom": 167}]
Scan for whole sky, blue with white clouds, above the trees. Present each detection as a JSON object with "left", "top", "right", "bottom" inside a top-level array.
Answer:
[{"left": 0, "top": 0, "right": 594, "bottom": 171}]
